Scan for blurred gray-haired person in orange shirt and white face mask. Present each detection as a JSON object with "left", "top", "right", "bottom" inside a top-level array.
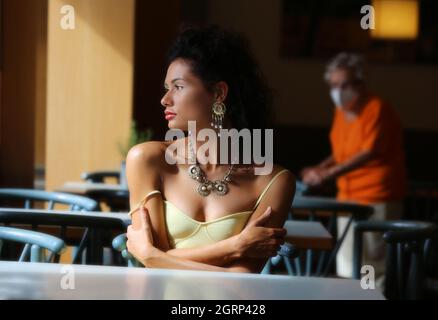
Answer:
[{"left": 301, "top": 53, "right": 406, "bottom": 285}]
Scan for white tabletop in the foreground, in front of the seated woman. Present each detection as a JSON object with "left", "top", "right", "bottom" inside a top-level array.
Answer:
[{"left": 0, "top": 262, "right": 384, "bottom": 300}]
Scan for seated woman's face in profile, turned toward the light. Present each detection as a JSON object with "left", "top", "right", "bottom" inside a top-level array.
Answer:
[{"left": 161, "top": 58, "right": 215, "bottom": 130}]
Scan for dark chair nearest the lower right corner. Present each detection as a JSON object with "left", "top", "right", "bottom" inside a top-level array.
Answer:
[{"left": 353, "top": 220, "right": 438, "bottom": 299}]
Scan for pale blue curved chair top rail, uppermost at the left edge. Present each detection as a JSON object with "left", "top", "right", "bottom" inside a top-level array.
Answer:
[{"left": 0, "top": 188, "right": 99, "bottom": 211}]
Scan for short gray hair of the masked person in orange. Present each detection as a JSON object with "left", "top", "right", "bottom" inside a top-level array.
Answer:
[{"left": 324, "top": 52, "right": 364, "bottom": 82}]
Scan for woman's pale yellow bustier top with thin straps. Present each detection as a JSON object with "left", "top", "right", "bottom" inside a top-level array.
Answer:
[{"left": 129, "top": 170, "right": 287, "bottom": 248}]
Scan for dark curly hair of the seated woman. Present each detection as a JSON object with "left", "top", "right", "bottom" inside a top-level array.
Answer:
[{"left": 168, "top": 26, "right": 272, "bottom": 130}]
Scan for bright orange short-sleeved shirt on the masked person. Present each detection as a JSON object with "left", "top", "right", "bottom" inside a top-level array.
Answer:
[{"left": 330, "top": 96, "right": 406, "bottom": 204}]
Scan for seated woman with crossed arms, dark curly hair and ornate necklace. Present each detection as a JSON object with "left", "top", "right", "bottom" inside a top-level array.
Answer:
[{"left": 127, "top": 27, "right": 295, "bottom": 272}]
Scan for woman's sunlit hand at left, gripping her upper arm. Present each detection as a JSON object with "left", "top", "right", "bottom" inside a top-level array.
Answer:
[{"left": 126, "top": 206, "right": 158, "bottom": 265}]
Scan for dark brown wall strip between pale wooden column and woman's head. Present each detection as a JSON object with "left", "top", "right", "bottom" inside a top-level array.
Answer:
[{"left": 133, "top": 0, "right": 181, "bottom": 139}]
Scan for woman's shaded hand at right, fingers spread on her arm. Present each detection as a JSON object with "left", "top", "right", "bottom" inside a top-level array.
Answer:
[{"left": 237, "top": 207, "right": 286, "bottom": 258}]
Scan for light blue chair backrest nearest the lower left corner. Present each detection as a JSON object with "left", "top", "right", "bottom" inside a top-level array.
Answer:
[{"left": 0, "top": 227, "right": 66, "bottom": 262}]
